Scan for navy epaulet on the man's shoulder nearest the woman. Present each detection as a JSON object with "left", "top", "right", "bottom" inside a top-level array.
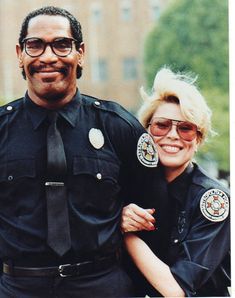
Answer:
[{"left": 82, "top": 94, "right": 140, "bottom": 127}]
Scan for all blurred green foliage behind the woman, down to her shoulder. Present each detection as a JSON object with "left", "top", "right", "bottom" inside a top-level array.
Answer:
[{"left": 144, "top": 0, "right": 229, "bottom": 171}]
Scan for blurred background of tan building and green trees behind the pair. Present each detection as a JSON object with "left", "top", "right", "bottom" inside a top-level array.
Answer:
[{"left": 0, "top": 0, "right": 230, "bottom": 185}]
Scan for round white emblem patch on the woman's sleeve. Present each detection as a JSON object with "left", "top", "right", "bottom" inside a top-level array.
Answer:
[{"left": 200, "top": 188, "right": 229, "bottom": 222}]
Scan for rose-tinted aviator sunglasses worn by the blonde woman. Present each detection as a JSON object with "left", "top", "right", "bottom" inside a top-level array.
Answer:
[{"left": 149, "top": 117, "right": 198, "bottom": 141}]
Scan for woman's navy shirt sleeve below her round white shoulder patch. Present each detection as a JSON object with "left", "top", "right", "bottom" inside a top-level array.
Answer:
[{"left": 170, "top": 189, "right": 230, "bottom": 296}]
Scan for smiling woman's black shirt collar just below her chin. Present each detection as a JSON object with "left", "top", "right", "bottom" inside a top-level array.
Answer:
[{"left": 168, "top": 163, "right": 194, "bottom": 204}]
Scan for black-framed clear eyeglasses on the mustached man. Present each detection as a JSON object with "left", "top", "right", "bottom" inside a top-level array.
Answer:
[{"left": 22, "top": 37, "right": 77, "bottom": 58}]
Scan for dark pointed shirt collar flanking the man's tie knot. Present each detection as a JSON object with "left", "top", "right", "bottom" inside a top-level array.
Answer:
[{"left": 24, "top": 90, "right": 81, "bottom": 130}]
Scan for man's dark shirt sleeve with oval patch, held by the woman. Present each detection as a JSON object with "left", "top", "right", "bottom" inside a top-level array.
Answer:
[{"left": 109, "top": 110, "right": 161, "bottom": 208}]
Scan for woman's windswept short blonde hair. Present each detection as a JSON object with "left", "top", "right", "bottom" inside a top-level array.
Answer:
[{"left": 137, "top": 67, "right": 212, "bottom": 143}]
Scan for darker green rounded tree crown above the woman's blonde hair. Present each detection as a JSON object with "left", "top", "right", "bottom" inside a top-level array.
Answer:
[{"left": 145, "top": 0, "right": 228, "bottom": 91}]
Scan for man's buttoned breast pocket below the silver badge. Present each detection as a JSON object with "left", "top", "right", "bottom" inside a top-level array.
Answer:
[{"left": 72, "top": 157, "right": 120, "bottom": 211}]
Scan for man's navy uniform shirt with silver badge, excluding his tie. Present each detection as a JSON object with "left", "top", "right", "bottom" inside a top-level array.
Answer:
[{"left": 0, "top": 91, "right": 161, "bottom": 266}]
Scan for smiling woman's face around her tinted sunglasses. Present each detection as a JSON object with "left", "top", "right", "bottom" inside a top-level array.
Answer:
[{"left": 149, "top": 103, "right": 198, "bottom": 181}]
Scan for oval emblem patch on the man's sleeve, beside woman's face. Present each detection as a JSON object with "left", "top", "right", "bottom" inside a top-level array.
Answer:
[{"left": 137, "top": 133, "right": 158, "bottom": 168}]
